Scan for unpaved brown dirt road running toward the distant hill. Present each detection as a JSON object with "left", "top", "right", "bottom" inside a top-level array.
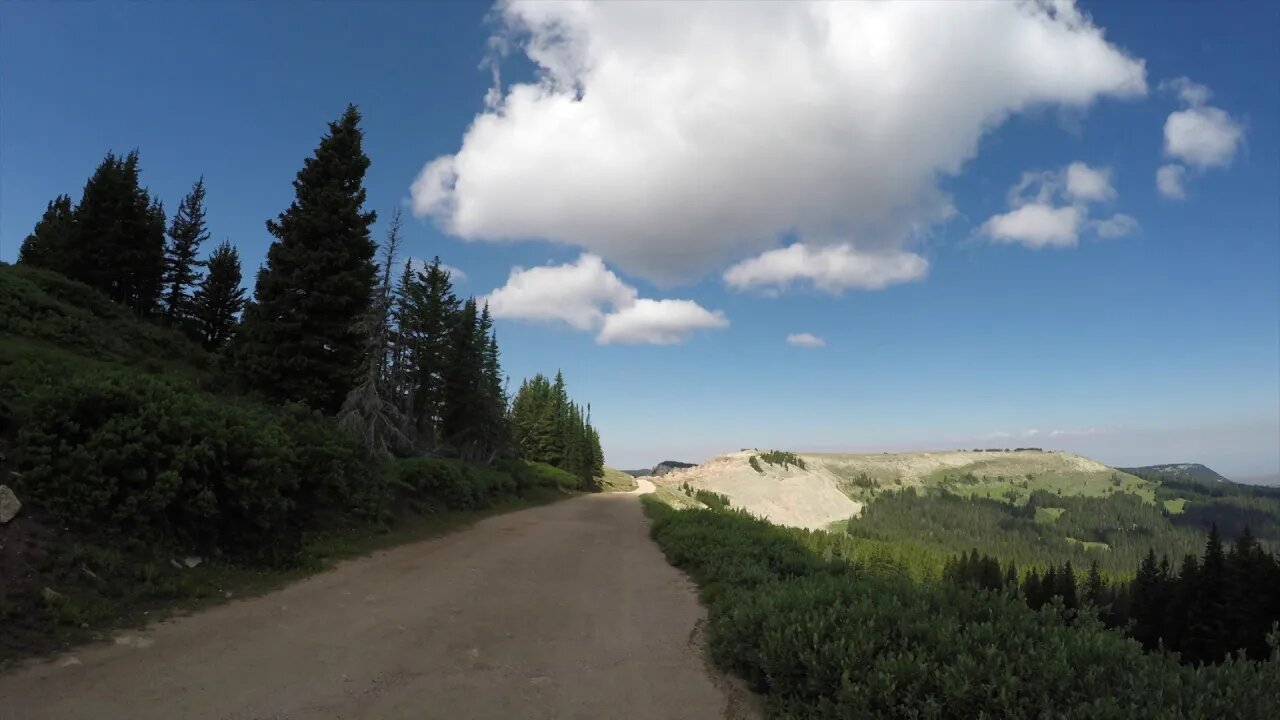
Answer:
[{"left": 0, "top": 480, "right": 749, "bottom": 720}]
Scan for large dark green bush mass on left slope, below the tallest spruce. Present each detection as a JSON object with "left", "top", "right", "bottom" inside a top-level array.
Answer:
[{"left": 17, "top": 372, "right": 379, "bottom": 564}]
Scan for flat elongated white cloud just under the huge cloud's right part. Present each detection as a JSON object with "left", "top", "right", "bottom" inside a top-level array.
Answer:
[{"left": 724, "top": 242, "right": 929, "bottom": 293}]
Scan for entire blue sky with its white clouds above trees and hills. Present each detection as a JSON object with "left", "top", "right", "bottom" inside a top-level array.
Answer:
[{"left": 0, "top": 1, "right": 1280, "bottom": 477}]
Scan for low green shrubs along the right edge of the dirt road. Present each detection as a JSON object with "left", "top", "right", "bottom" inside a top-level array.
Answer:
[{"left": 645, "top": 498, "right": 1280, "bottom": 720}]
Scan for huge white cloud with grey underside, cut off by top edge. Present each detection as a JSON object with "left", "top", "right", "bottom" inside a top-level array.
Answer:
[{"left": 412, "top": 0, "right": 1146, "bottom": 287}]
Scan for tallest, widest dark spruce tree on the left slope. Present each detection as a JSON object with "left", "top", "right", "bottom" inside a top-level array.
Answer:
[{"left": 233, "top": 105, "right": 376, "bottom": 414}]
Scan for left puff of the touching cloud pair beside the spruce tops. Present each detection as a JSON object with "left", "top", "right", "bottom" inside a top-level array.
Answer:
[{"left": 485, "top": 254, "right": 636, "bottom": 331}]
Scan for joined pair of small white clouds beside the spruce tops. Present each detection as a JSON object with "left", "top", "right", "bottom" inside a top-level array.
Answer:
[{"left": 483, "top": 254, "right": 728, "bottom": 345}]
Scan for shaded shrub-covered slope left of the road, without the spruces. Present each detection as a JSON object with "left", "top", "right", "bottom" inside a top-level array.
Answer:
[{"left": 0, "top": 265, "right": 579, "bottom": 666}]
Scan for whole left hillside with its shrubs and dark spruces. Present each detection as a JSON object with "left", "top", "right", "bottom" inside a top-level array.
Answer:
[{"left": 0, "top": 106, "right": 603, "bottom": 661}]
